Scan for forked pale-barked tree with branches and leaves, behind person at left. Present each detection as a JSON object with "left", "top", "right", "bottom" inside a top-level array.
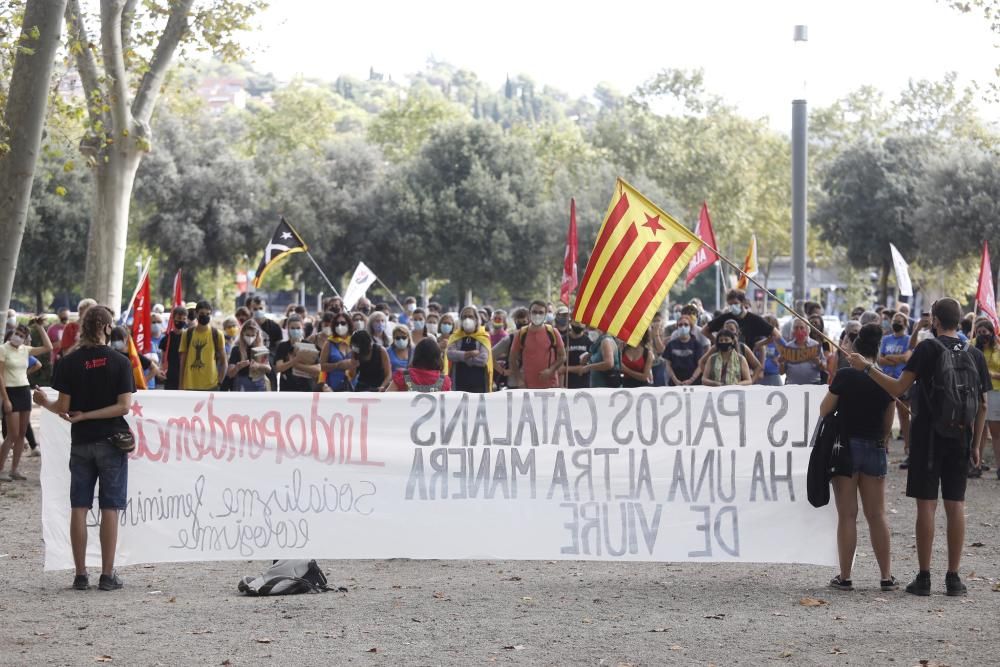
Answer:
[{"left": 66, "top": 0, "right": 266, "bottom": 309}]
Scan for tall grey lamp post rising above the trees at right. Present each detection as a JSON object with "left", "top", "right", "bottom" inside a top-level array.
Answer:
[{"left": 792, "top": 25, "right": 809, "bottom": 303}]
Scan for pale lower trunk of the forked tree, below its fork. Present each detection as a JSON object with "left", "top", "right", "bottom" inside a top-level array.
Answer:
[{"left": 83, "top": 142, "right": 143, "bottom": 313}]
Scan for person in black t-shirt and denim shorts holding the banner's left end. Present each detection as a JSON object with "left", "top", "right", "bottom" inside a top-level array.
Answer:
[{"left": 35, "top": 306, "right": 135, "bottom": 591}]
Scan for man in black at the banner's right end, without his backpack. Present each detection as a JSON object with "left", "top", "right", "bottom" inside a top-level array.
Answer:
[{"left": 850, "top": 299, "right": 992, "bottom": 595}]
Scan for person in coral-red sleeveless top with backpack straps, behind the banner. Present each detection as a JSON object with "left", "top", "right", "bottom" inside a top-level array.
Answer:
[{"left": 509, "top": 301, "right": 566, "bottom": 389}]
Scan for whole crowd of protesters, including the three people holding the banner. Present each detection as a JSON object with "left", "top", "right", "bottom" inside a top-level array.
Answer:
[{"left": 0, "top": 289, "right": 1000, "bottom": 595}]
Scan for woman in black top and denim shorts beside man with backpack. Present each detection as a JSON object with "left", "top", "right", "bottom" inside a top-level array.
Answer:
[{"left": 820, "top": 324, "right": 899, "bottom": 591}]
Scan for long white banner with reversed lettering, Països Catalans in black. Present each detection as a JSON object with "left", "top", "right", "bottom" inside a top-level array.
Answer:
[{"left": 41, "top": 386, "right": 836, "bottom": 570}]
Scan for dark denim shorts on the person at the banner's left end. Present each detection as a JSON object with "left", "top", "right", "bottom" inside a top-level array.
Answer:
[{"left": 69, "top": 441, "right": 128, "bottom": 510}]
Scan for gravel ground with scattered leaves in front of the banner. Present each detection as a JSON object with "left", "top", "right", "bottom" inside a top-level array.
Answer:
[{"left": 0, "top": 412, "right": 1000, "bottom": 667}]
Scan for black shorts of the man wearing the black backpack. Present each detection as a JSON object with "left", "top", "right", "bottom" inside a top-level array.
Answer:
[{"left": 906, "top": 434, "right": 969, "bottom": 501}]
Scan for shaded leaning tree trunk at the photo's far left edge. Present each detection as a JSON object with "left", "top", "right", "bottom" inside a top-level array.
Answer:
[{"left": 0, "top": 0, "right": 66, "bottom": 312}]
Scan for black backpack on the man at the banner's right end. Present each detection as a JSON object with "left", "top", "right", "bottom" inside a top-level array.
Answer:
[{"left": 924, "top": 338, "right": 982, "bottom": 442}]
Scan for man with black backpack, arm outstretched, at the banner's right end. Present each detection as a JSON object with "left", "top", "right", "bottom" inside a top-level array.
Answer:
[{"left": 850, "top": 298, "right": 991, "bottom": 596}]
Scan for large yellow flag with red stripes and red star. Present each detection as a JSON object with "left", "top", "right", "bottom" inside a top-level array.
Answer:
[{"left": 573, "top": 178, "right": 702, "bottom": 345}]
